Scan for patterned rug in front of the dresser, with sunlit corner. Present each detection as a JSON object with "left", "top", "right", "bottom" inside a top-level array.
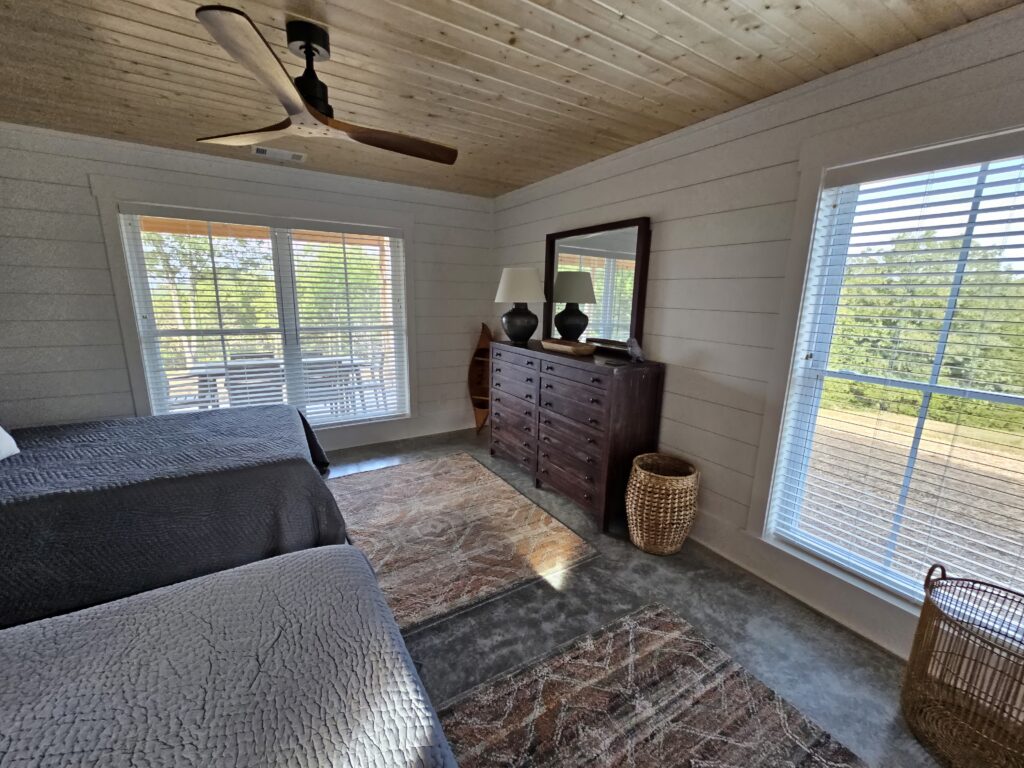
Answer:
[{"left": 328, "top": 454, "right": 595, "bottom": 630}]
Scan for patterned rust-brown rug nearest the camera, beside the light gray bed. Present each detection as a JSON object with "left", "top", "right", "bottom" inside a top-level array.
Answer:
[{"left": 440, "top": 605, "right": 866, "bottom": 768}]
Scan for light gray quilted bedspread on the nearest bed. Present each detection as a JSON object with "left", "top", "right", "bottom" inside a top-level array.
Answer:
[{"left": 0, "top": 545, "right": 456, "bottom": 768}]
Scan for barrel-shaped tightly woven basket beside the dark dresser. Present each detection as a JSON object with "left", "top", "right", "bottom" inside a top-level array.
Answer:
[{"left": 626, "top": 454, "right": 700, "bottom": 555}]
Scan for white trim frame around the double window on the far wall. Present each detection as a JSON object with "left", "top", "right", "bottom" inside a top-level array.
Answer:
[{"left": 89, "top": 179, "right": 420, "bottom": 434}]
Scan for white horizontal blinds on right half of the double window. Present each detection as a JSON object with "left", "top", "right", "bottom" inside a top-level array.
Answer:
[{"left": 291, "top": 230, "right": 409, "bottom": 422}]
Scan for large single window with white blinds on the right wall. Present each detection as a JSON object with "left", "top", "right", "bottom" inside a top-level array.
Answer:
[{"left": 769, "top": 158, "right": 1024, "bottom": 598}]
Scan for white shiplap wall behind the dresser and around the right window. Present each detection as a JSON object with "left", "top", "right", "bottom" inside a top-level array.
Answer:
[{"left": 495, "top": 7, "right": 1024, "bottom": 653}]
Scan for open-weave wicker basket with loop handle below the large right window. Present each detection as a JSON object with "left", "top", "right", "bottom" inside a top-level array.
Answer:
[{"left": 901, "top": 565, "right": 1024, "bottom": 768}]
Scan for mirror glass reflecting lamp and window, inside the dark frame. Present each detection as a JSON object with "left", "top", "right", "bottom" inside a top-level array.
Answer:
[{"left": 552, "top": 226, "right": 639, "bottom": 343}]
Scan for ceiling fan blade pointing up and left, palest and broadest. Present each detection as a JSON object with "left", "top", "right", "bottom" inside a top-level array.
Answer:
[{"left": 196, "top": 5, "right": 306, "bottom": 116}]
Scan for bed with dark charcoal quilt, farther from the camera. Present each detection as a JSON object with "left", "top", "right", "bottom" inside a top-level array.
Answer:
[{"left": 0, "top": 406, "right": 345, "bottom": 628}]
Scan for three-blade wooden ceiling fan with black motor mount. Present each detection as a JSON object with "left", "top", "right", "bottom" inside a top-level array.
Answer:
[{"left": 196, "top": 5, "right": 459, "bottom": 165}]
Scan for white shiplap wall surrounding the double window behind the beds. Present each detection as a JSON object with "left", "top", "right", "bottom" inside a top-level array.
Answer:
[{"left": 0, "top": 124, "right": 500, "bottom": 446}]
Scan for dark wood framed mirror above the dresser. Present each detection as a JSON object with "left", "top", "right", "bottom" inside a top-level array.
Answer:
[{"left": 542, "top": 216, "right": 650, "bottom": 348}]
